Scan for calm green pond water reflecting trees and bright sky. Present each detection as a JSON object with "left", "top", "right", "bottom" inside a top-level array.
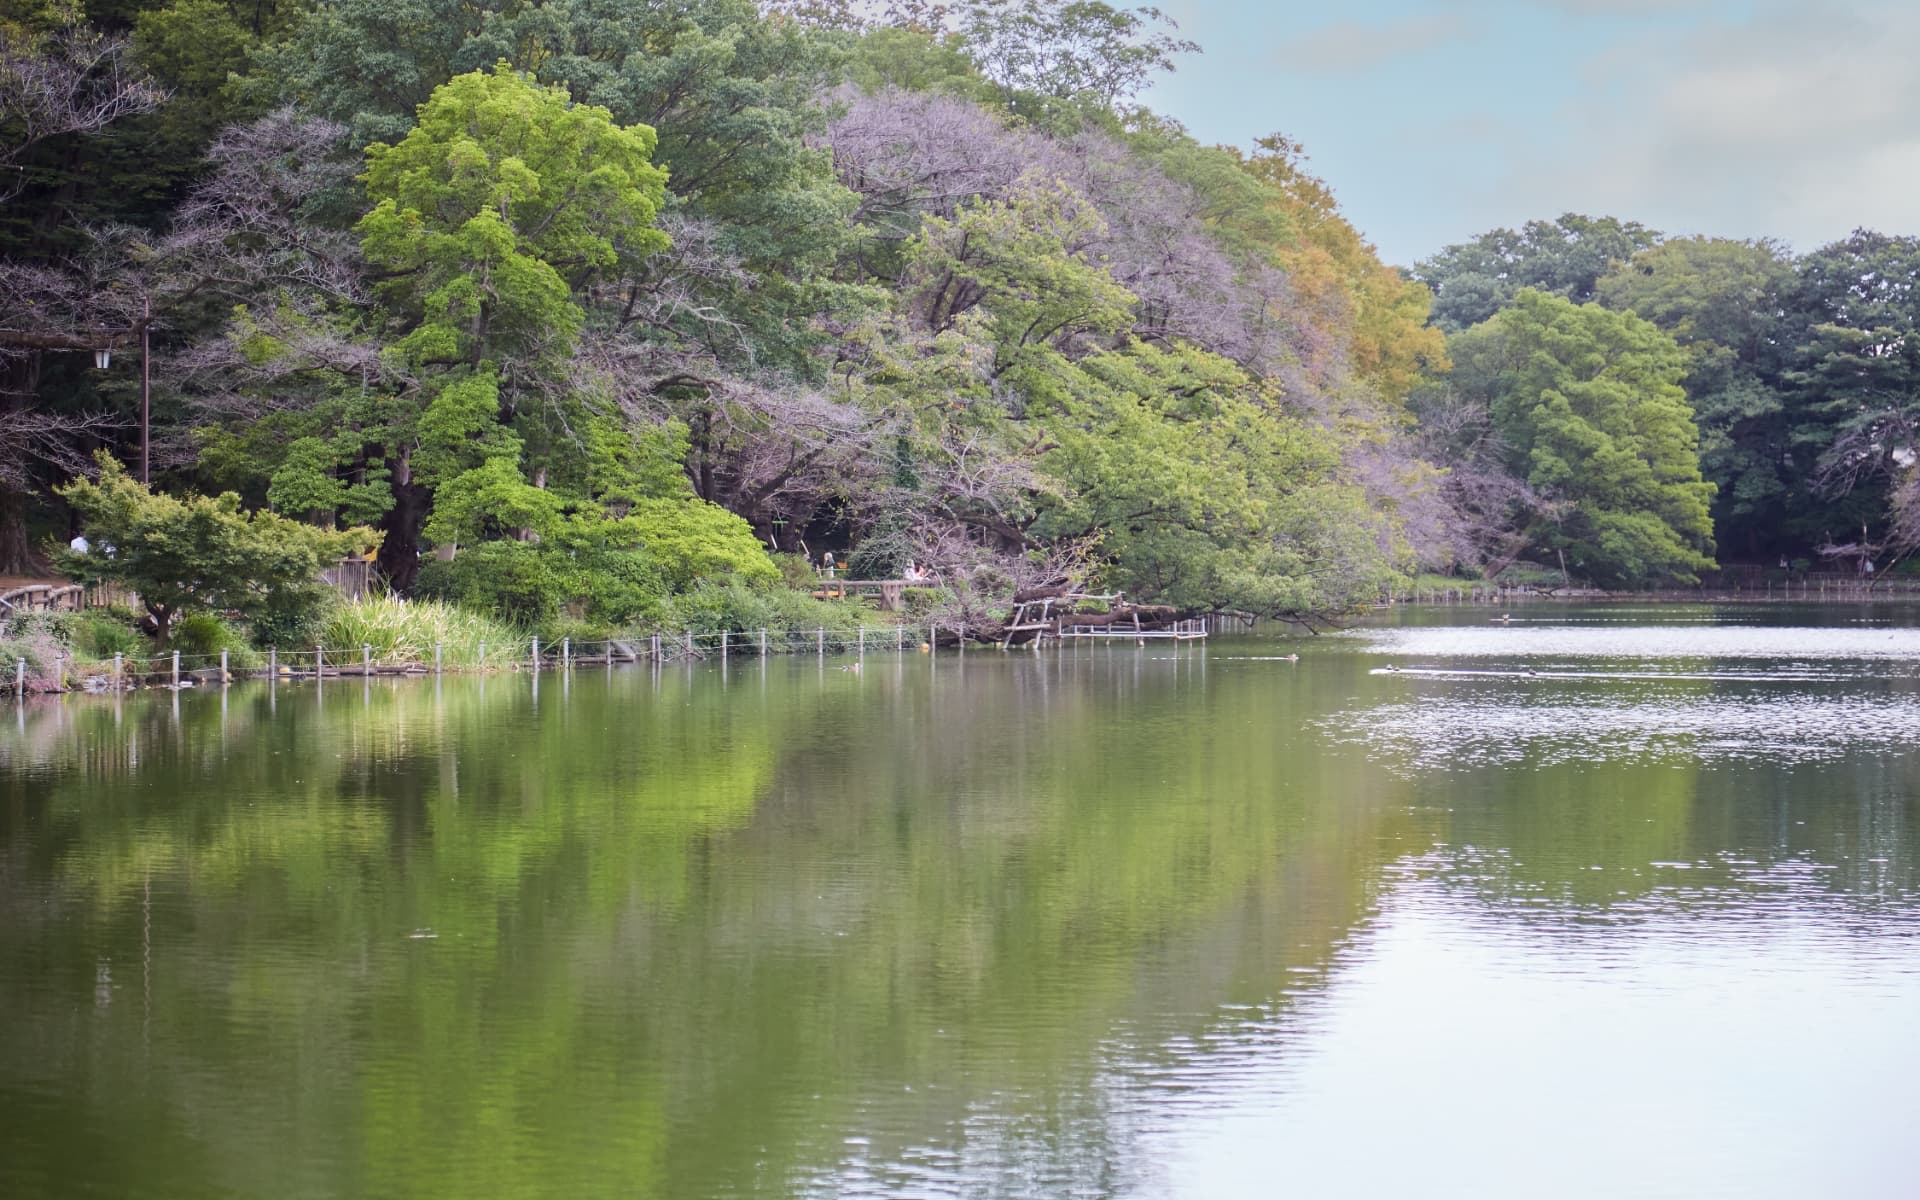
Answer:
[{"left": 0, "top": 605, "right": 1920, "bottom": 1200}]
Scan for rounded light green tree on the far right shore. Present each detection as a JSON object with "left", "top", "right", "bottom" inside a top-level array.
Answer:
[{"left": 1453, "top": 288, "right": 1713, "bottom": 586}]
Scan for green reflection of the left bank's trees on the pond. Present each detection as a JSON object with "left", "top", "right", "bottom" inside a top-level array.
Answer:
[{"left": 0, "top": 660, "right": 1428, "bottom": 1194}]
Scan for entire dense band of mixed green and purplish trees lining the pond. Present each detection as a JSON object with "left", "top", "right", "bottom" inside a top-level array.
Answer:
[{"left": 0, "top": 0, "right": 1920, "bottom": 645}]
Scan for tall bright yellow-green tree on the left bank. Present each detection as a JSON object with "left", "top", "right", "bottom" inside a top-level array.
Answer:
[{"left": 359, "top": 63, "right": 666, "bottom": 572}]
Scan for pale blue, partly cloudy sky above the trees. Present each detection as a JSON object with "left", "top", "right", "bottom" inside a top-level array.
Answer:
[{"left": 1142, "top": 0, "right": 1920, "bottom": 265}]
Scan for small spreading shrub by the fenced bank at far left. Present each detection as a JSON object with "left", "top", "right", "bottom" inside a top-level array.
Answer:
[{"left": 56, "top": 455, "right": 378, "bottom": 641}]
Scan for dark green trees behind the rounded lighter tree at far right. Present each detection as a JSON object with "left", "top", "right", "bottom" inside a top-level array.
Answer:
[{"left": 1415, "top": 213, "right": 1920, "bottom": 570}]
